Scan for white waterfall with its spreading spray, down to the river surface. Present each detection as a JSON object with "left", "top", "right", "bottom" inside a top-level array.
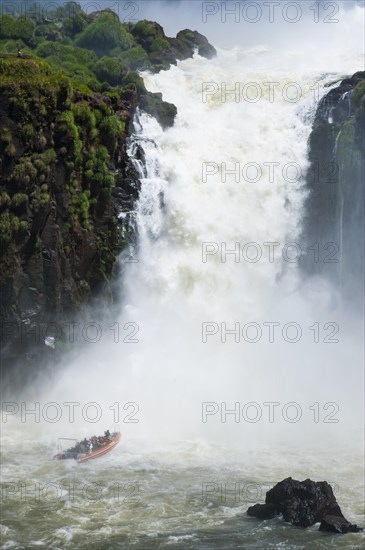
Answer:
[{"left": 19, "top": 48, "right": 362, "bottom": 448}]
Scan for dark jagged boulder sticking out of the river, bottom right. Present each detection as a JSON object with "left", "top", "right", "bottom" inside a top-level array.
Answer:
[{"left": 247, "top": 477, "right": 362, "bottom": 533}]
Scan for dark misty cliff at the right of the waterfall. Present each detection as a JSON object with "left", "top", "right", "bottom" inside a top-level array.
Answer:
[{"left": 304, "top": 72, "right": 365, "bottom": 302}]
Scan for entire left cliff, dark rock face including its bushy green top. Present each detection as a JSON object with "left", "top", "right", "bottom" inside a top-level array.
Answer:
[{"left": 0, "top": 6, "right": 215, "bottom": 376}]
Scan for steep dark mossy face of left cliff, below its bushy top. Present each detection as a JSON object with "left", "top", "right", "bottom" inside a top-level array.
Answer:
[{"left": 0, "top": 59, "right": 137, "bottom": 374}]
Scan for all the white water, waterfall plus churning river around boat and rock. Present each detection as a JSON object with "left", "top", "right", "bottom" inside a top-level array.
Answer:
[{"left": 2, "top": 49, "right": 364, "bottom": 550}]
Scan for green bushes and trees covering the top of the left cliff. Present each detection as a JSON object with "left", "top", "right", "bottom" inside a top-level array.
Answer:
[{"left": 0, "top": 2, "right": 214, "bottom": 91}]
